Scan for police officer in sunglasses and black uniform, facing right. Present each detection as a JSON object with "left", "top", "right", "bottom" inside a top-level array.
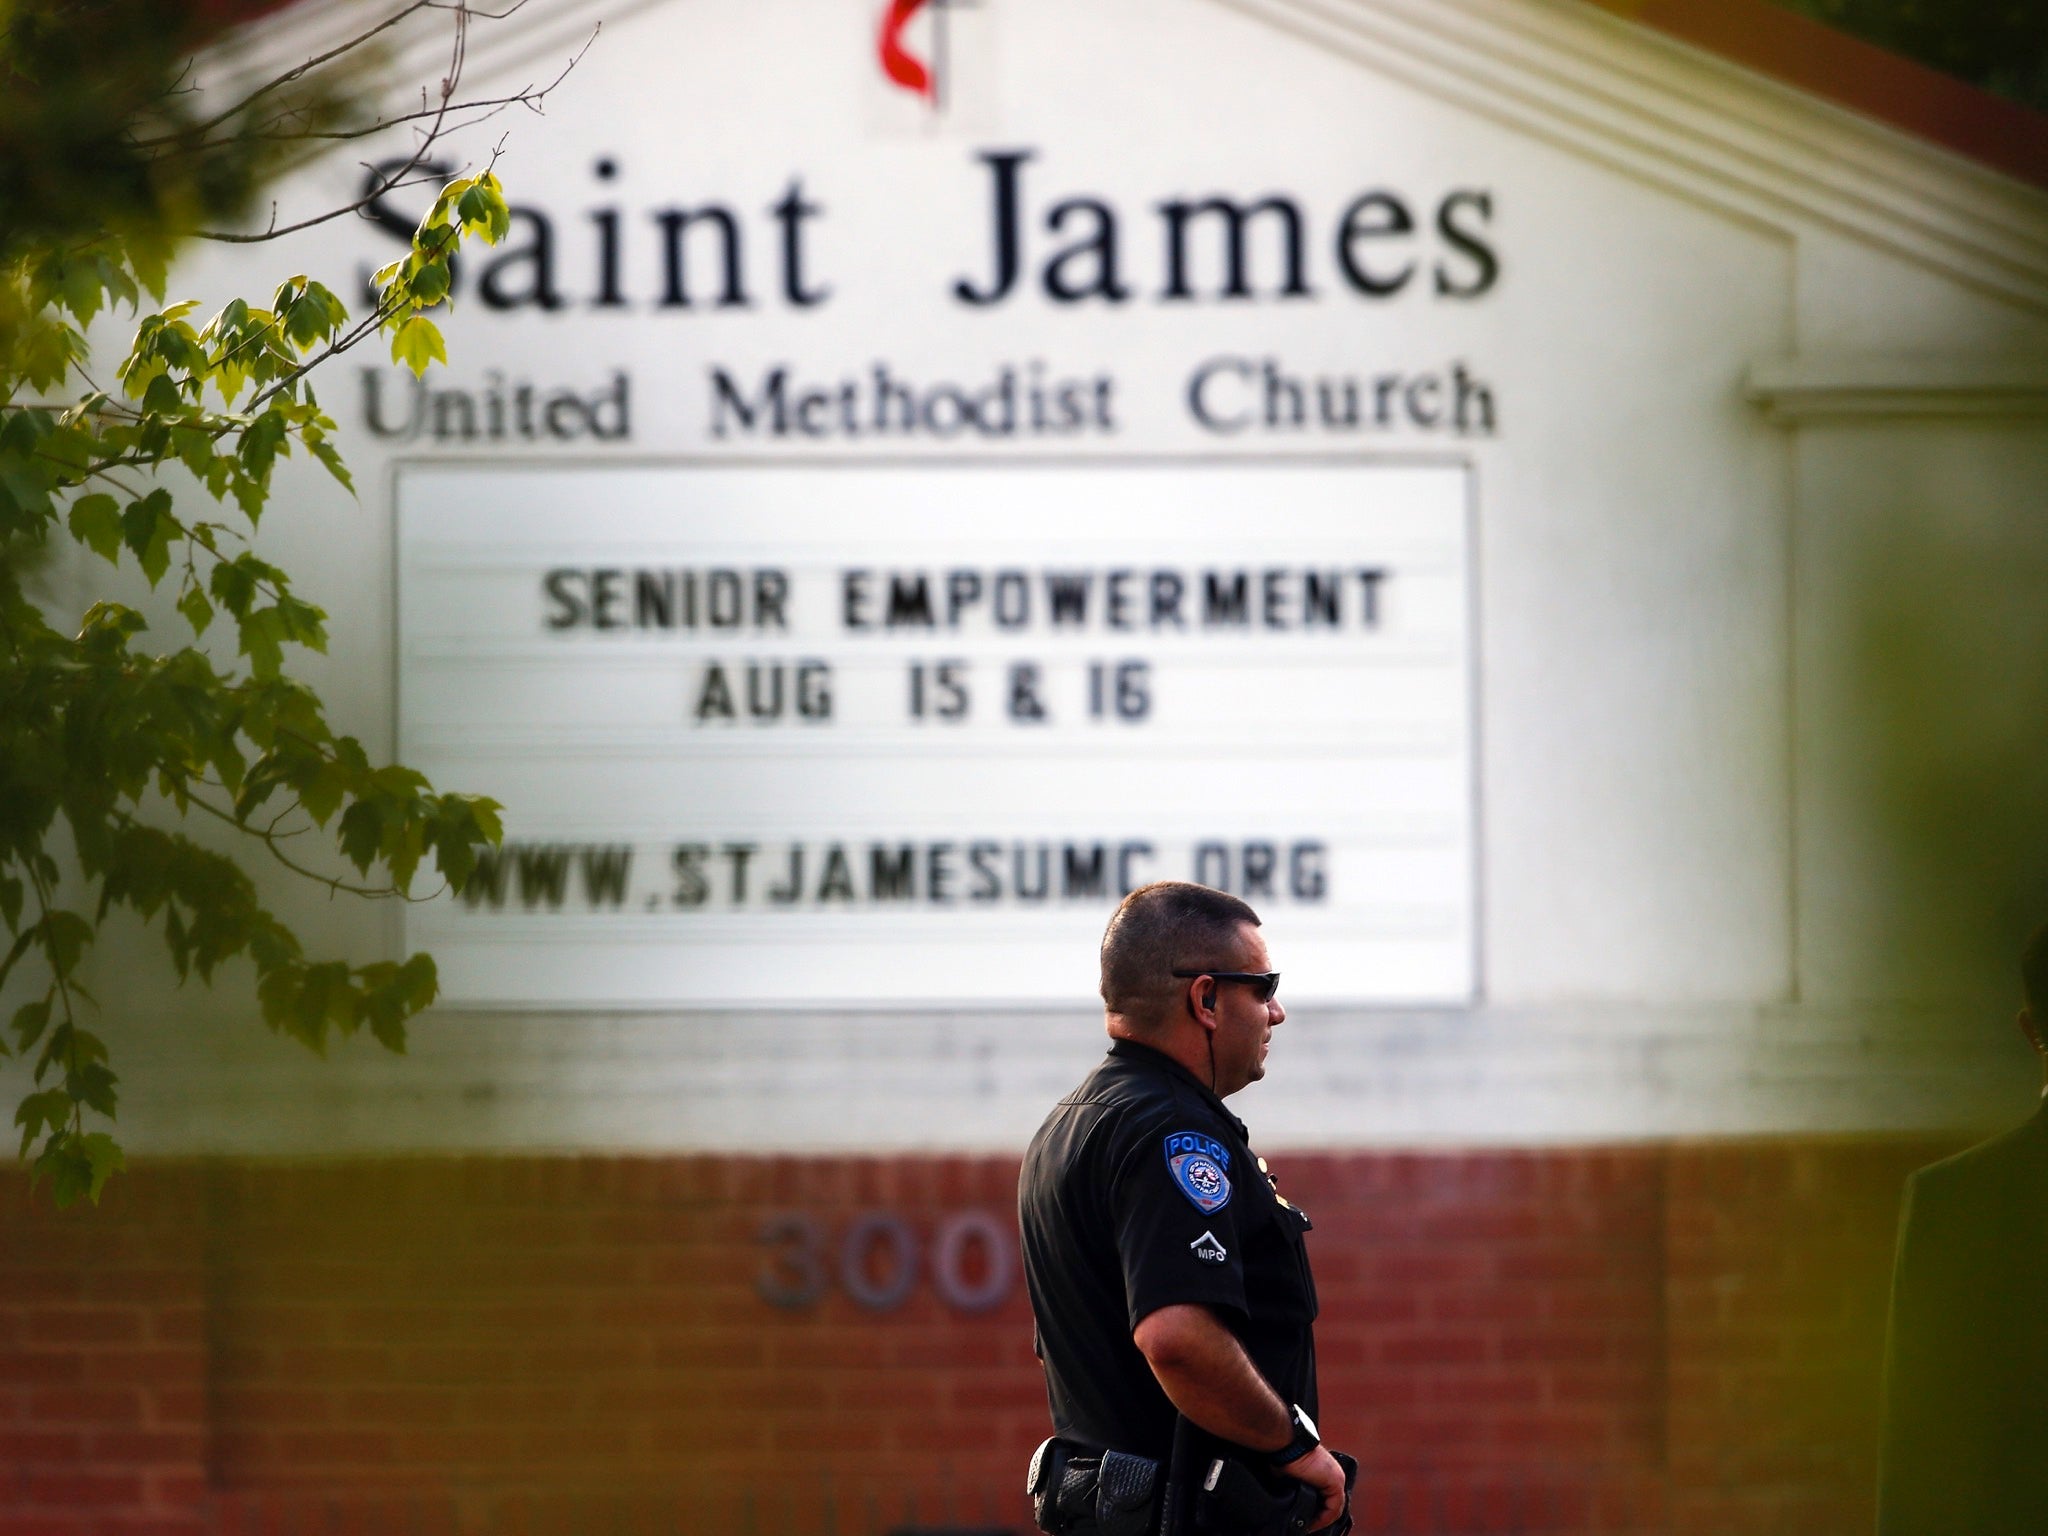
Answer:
[{"left": 1018, "top": 881, "right": 1346, "bottom": 1530}]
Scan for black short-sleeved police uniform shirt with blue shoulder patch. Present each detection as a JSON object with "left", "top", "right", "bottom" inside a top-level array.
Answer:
[{"left": 1018, "top": 1040, "right": 1317, "bottom": 1460}]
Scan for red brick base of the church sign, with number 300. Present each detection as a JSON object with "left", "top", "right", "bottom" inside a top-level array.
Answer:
[{"left": 0, "top": 1143, "right": 1948, "bottom": 1536}]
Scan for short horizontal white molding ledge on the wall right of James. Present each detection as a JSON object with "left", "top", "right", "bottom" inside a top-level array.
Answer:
[{"left": 1743, "top": 354, "right": 2048, "bottom": 426}]
